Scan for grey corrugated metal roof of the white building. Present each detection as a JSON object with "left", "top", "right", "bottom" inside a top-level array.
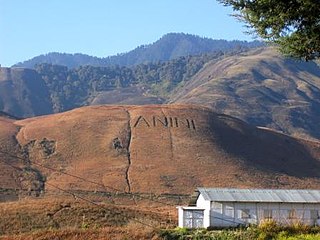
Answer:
[{"left": 198, "top": 188, "right": 320, "bottom": 203}]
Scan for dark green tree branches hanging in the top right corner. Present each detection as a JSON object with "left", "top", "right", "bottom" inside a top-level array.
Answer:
[{"left": 218, "top": 0, "right": 320, "bottom": 61}]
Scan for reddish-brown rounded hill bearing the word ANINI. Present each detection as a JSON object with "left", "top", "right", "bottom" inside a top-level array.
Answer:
[{"left": 0, "top": 105, "right": 320, "bottom": 197}]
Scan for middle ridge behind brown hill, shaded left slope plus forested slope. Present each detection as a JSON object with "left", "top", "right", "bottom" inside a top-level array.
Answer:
[{"left": 0, "top": 52, "right": 223, "bottom": 117}]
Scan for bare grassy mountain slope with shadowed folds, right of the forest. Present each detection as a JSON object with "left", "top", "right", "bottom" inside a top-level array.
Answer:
[{"left": 171, "top": 48, "right": 320, "bottom": 139}]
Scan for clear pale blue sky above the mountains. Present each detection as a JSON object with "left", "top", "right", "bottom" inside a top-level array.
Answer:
[{"left": 0, "top": 0, "right": 252, "bottom": 66}]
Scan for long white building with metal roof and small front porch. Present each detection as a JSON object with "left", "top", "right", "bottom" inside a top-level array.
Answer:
[{"left": 178, "top": 188, "right": 320, "bottom": 228}]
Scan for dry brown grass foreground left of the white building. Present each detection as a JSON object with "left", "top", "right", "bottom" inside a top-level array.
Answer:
[{"left": 0, "top": 196, "right": 176, "bottom": 240}]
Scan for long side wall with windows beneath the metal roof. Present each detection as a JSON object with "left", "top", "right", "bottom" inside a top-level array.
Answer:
[{"left": 209, "top": 202, "right": 320, "bottom": 227}]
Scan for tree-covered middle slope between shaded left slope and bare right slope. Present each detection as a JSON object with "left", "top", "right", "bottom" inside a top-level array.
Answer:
[{"left": 35, "top": 52, "right": 222, "bottom": 112}]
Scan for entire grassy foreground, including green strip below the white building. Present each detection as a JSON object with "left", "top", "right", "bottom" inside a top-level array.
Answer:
[{"left": 0, "top": 196, "right": 320, "bottom": 240}]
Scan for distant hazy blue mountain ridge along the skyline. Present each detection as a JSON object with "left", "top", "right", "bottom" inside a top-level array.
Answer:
[{"left": 14, "top": 33, "right": 263, "bottom": 68}]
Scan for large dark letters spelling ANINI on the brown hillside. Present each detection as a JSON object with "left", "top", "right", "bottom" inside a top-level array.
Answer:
[{"left": 133, "top": 116, "right": 196, "bottom": 130}]
